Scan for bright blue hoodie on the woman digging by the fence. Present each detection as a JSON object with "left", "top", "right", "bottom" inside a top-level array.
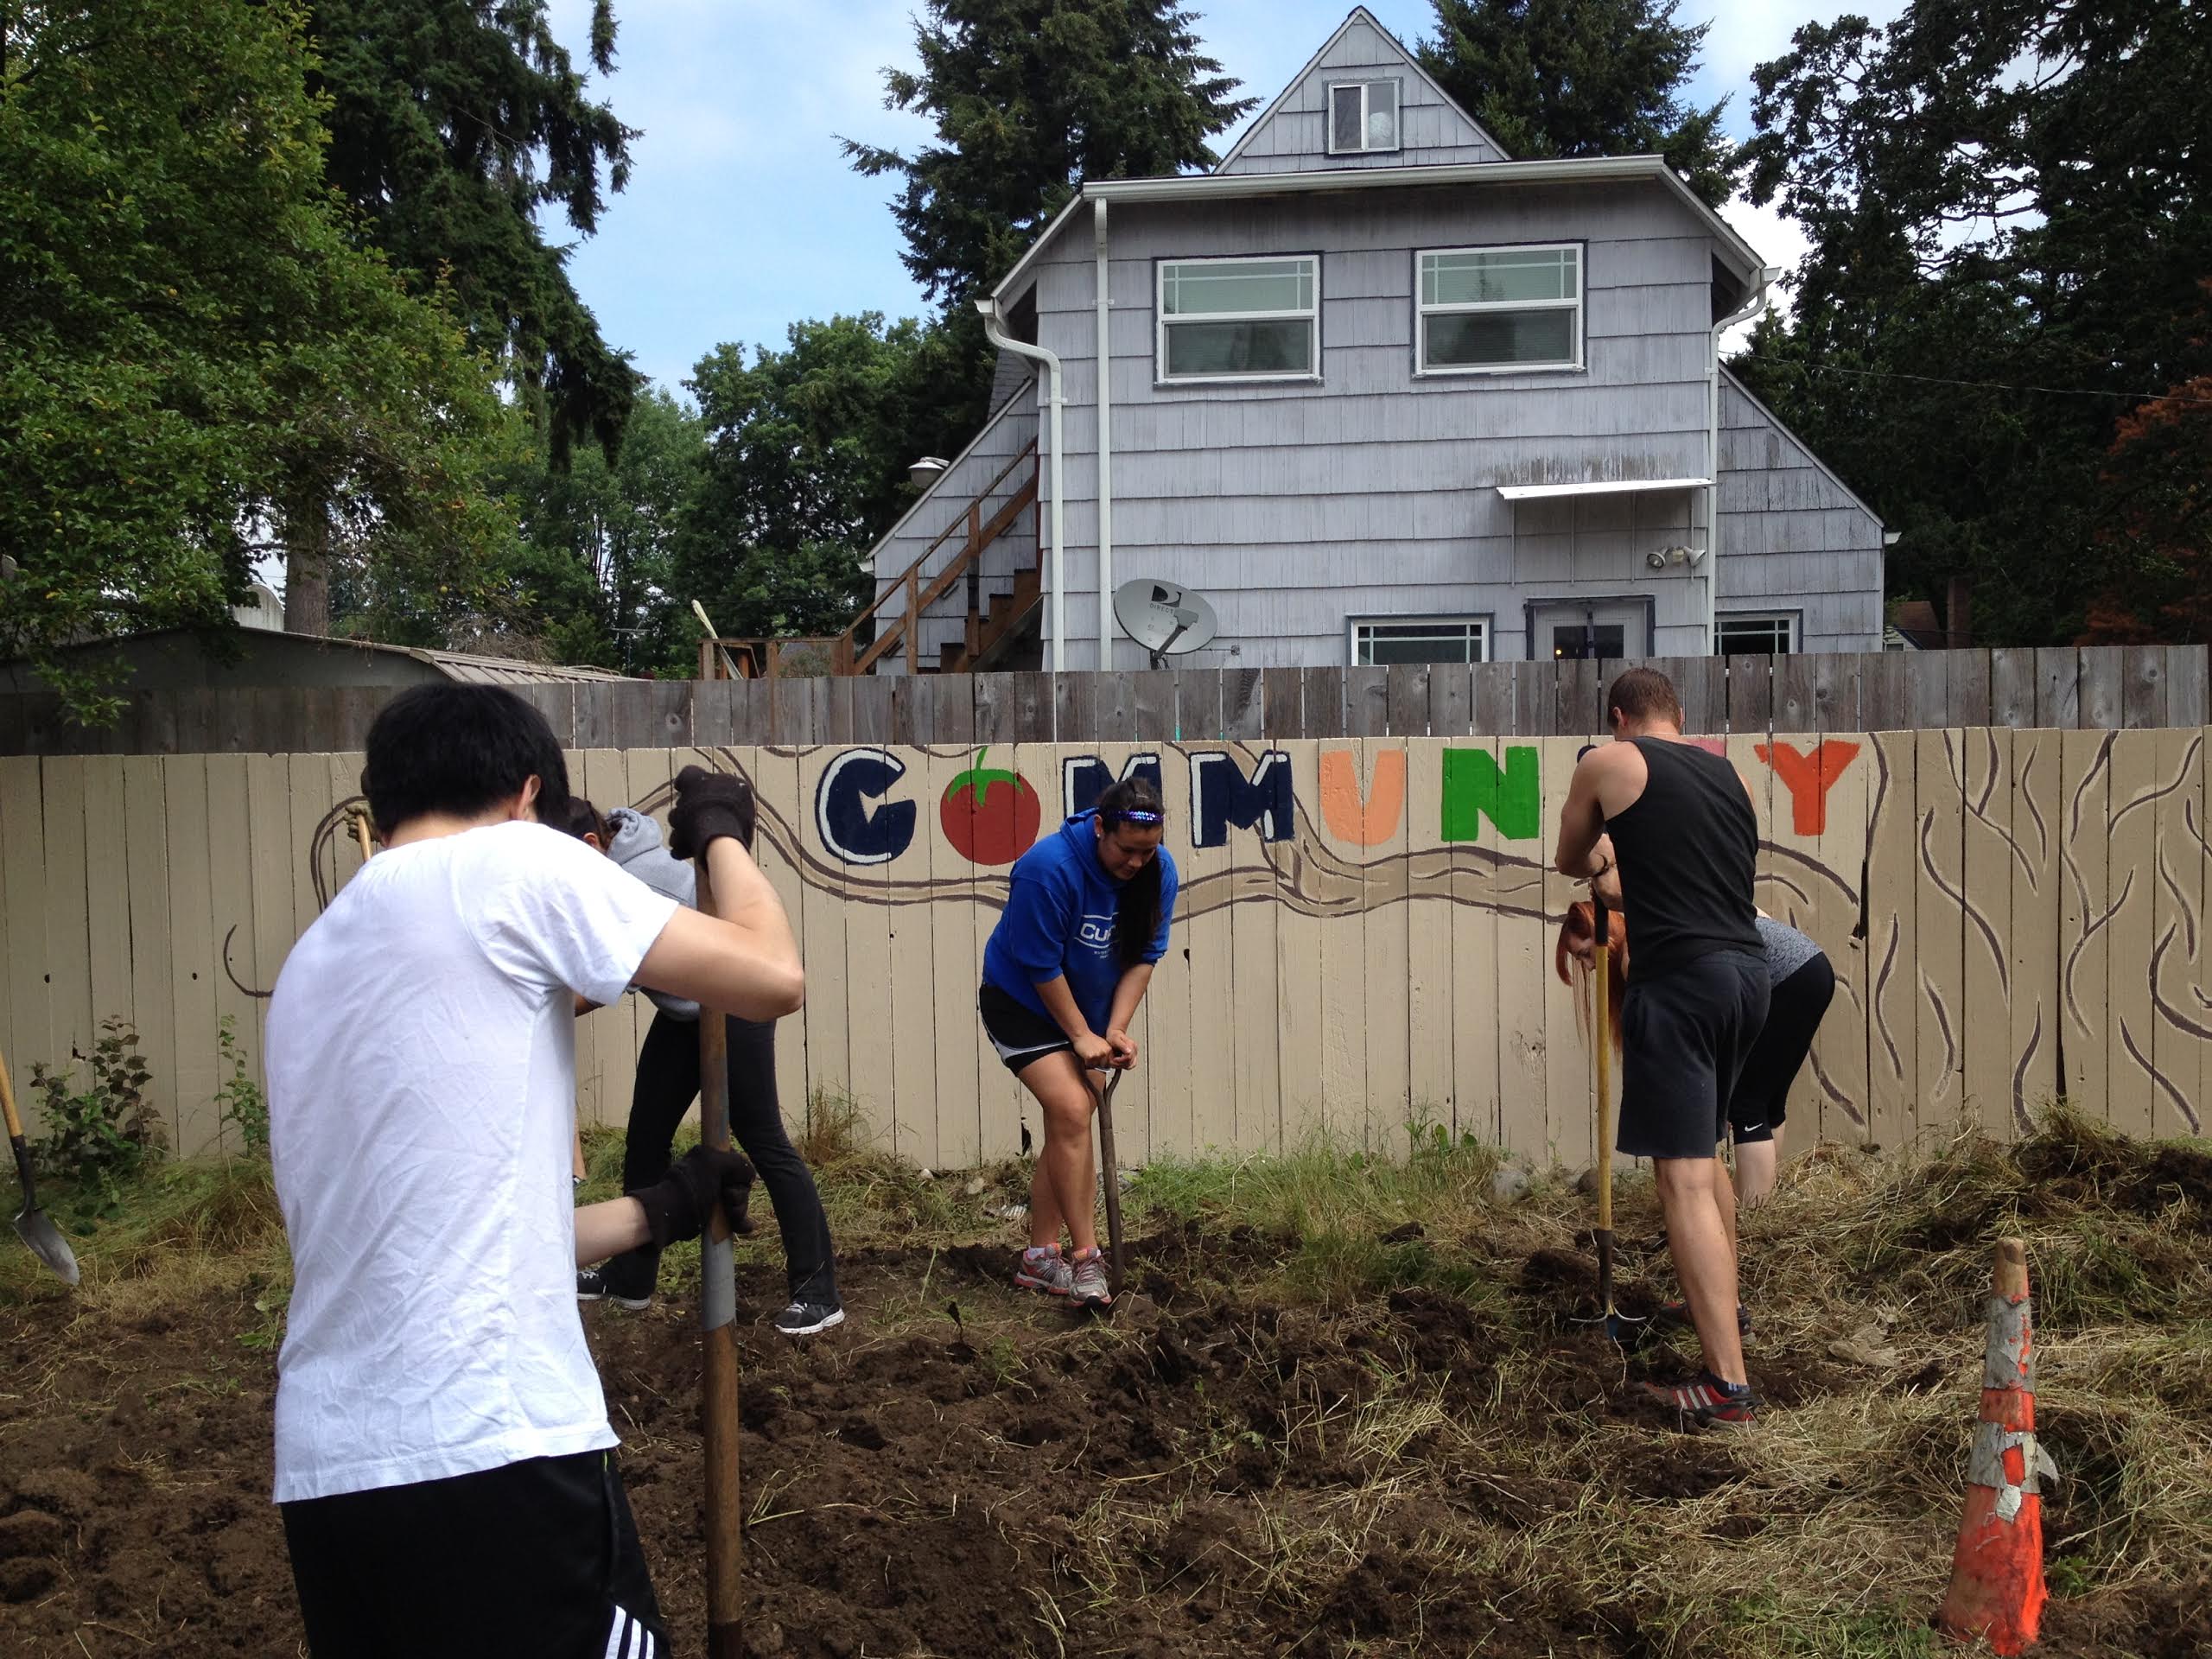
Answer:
[{"left": 982, "top": 810, "right": 1177, "bottom": 1033}]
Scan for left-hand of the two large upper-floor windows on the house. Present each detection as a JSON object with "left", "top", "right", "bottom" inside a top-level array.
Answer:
[{"left": 1154, "top": 254, "right": 1320, "bottom": 380}]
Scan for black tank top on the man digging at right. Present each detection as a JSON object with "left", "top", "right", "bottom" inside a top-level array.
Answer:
[{"left": 1606, "top": 736, "right": 1765, "bottom": 976}]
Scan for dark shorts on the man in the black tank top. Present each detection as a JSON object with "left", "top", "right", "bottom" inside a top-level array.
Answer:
[{"left": 1617, "top": 951, "right": 1767, "bottom": 1157}]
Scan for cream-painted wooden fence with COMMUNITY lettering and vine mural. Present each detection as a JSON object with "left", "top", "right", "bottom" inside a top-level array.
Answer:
[{"left": 0, "top": 728, "right": 2212, "bottom": 1168}]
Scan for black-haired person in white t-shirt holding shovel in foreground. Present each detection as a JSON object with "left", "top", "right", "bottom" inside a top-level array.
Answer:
[{"left": 268, "top": 683, "right": 805, "bottom": 1659}]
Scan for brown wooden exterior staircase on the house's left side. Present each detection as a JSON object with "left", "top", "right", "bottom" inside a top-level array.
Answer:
[{"left": 699, "top": 438, "right": 1044, "bottom": 679}]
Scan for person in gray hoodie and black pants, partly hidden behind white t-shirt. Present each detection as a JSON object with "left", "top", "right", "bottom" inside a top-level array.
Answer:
[{"left": 570, "top": 803, "right": 845, "bottom": 1338}]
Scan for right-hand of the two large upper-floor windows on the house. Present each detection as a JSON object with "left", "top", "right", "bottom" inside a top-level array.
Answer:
[{"left": 1414, "top": 241, "right": 1581, "bottom": 374}]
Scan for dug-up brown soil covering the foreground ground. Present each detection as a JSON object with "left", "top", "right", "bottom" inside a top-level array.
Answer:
[{"left": 0, "top": 1228, "right": 2212, "bottom": 1659}]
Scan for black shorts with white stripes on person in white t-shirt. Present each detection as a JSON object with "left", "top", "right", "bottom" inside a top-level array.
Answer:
[{"left": 283, "top": 1451, "right": 668, "bottom": 1659}]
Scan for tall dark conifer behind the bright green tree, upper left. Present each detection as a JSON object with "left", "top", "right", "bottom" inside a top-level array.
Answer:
[{"left": 285, "top": 0, "right": 637, "bottom": 632}]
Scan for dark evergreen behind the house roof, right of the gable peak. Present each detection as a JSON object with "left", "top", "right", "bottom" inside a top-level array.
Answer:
[{"left": 1418, "top": 0, "right": 1737, "bottom": 206}]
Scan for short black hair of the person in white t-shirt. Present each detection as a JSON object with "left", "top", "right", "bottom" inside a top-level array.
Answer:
[{"left": 360, "top": 681, "right": 569, "bottom": 841}]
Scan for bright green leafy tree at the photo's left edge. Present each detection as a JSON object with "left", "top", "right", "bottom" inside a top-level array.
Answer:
[{"left": 0, "top": 0, "right": 505, "bottom": 719}]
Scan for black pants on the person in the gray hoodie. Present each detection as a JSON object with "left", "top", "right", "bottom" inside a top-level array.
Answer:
[{"left": 606, "top": 1011, "right": 836, "bottom": 1303}]
